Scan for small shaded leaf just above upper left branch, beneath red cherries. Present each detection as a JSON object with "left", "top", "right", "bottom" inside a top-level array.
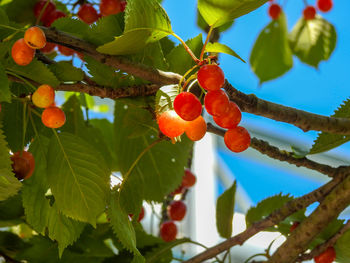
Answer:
[{"left": 51, "top": 17, "right": 90, "bottom": 38}]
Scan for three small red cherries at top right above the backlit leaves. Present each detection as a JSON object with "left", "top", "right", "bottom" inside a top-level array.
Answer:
[{"left": 268, "top": 0, "right": 333, "bottom": 20}]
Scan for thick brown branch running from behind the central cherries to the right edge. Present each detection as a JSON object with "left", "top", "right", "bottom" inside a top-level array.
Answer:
[{"left": 224, "top": 82, "right": 350, "bottom": 135}]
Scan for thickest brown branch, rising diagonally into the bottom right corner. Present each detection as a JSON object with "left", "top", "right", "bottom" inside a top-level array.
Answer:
[{"left": 268, "top": 174, "right": 350, "bottom": 263}]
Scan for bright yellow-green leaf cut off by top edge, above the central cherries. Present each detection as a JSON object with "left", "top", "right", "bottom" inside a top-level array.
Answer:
[{"left": 198, "top": 0, "right": 268, "bottom": 27}]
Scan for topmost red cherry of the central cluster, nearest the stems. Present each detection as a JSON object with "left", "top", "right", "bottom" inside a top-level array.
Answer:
[{"left": 197, "top": 64, "right": 225, "bottom": 90}]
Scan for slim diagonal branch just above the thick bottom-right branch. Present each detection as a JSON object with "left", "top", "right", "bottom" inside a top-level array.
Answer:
[{"left": 184, "top": 175, "right": 345, "bottom": 263}]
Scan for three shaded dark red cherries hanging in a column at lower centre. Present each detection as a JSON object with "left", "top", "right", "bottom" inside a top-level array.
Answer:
[{"left": 159, "top": 169, "right": 196, "bottom": 242}]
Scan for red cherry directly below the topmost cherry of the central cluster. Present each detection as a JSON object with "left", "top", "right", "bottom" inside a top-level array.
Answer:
[{"left": 204, "top": 90, "right": 230, "bottom": 116}]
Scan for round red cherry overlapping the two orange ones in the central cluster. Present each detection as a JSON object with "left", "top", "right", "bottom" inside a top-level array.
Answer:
[{"left": 174, "top": 92, "right": 202, "bottom": 121}]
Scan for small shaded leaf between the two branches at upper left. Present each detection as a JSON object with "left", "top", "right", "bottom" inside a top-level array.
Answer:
[{"left": 49, "top": 61, "right": 84, "bottom": 82}]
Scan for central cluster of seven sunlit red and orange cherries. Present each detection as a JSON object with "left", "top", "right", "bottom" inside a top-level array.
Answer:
[{"left": 158, "top": 64, "right": 250, "bottom": 153}]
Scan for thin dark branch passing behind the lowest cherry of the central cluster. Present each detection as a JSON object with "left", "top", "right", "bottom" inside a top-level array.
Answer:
[{"left": 207, "top": 123, "right": 350, "bottom": 177}]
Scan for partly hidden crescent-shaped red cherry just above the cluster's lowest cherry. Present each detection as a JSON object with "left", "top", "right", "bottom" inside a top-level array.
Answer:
[{"left": 213, "top": 101, "right": 242, "bottom": 129}]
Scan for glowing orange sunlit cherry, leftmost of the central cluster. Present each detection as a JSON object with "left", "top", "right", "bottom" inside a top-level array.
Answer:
[{"left": 158, "top": 110, "right": 186, "bottom": 138}]
